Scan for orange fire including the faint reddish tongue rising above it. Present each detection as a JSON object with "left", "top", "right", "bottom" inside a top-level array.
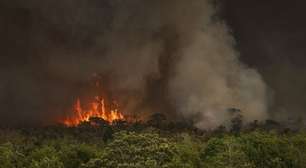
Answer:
[{"left": 60, "top": 74, "right": 126, "bottom": 127}]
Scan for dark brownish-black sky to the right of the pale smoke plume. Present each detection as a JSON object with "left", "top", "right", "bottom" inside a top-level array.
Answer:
[{"left": 223, "top": 0, "right": 306, "bottom": 116}]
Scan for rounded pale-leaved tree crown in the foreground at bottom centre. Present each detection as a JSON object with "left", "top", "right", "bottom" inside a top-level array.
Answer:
[{"left": 101, "top": 132, "right": 175, "bottom": 168}]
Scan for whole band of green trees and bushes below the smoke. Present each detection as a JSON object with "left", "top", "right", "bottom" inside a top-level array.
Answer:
[{"left": 0, "top": 116, "right": 306, "bottom": 168}]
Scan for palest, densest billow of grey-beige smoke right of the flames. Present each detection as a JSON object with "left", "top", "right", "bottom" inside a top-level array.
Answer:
[{"left": 170, "top": 23, "right": 267, "bottom": 128}]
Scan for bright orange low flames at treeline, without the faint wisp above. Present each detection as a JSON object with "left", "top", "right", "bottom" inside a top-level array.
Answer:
[{"left": 63, "top": 96, "right": 124, "bottom": 126}]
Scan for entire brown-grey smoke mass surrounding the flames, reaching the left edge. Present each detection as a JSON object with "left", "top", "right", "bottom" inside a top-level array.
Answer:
[{"left": 0, "top": 0, "right": 268, "bottom": 128}]
